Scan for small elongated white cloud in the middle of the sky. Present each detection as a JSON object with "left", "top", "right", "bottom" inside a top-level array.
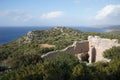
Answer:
[{"left": 41, "top": 11, "right": 64, "bottom": 19}]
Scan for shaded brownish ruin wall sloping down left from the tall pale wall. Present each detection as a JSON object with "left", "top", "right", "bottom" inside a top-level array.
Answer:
[{"left": 41, "top": 41, "right": 89, "bottom": 60}]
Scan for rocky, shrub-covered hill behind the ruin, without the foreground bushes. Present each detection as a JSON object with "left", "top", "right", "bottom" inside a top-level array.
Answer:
[{"left": 0, "top": 27, "right": 120, "bottom": 61}]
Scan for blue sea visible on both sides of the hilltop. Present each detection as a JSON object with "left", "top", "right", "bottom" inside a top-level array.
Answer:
[{"left": 0, "top": 26, "right": 106, "bottom": 44}]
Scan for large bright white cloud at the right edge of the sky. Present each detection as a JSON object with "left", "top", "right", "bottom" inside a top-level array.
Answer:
[{"left": 95, "top": 5, "right": 120, "bottom": 21}]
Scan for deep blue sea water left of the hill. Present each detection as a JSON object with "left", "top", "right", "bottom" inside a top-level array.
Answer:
[{"left": 0, "top": 27, "right": 50, "bottom": 44}]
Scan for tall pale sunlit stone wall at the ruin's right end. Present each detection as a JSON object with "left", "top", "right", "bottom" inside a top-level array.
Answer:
[{"left": 88, "top": 36, "right": 120, "bottom": 62}]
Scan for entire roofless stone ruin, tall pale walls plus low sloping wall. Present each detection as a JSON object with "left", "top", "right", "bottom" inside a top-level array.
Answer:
[{"left": 41, "top": 36, "right": 120, "bottom": 63}]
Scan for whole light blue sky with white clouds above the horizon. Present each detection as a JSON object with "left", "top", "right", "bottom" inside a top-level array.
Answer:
[{"left": 0, "top": 0, "right": 120, "bottom": 26}]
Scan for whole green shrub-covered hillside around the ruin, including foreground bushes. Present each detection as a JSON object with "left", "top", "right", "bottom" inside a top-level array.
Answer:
[{"left": 0, "top": 27, "right": 120, "bottom": 80}]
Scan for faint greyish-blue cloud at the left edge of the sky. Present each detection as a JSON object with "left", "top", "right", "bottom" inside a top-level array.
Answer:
[{"left": 0, "top": 9, "right": 33, "bottom": 22}]
